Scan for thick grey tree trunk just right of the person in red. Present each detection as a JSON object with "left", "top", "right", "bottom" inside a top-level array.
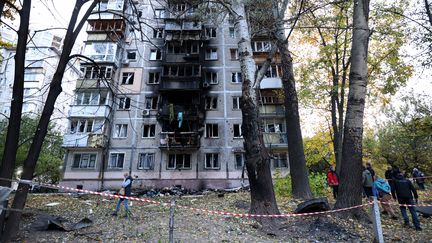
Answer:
[{"left": 335, "top": 0, "right": 370, "bottom": 214}]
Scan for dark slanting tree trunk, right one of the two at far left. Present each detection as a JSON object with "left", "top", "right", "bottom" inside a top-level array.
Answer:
[{"left": 1, "top": 0, "right": 99, "bottom": 242}]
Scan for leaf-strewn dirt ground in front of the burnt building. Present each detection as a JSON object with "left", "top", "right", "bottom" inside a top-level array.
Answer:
[{"left": 11, "top": 192, "right": 432, "bottom": 242}]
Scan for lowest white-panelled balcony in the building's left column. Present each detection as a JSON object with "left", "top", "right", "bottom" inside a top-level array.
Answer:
[{"left": 63, "top": 133, "right": 108, "bottom": 148}]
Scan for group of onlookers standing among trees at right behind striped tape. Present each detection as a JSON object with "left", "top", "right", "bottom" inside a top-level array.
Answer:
[{"left": 327, "top": 163, "right": 425, "bottom": 230}]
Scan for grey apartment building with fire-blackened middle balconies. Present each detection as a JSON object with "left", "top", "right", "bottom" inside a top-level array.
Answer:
[{"left": 61, "top": 0, "right": 288, "bottom": 189}]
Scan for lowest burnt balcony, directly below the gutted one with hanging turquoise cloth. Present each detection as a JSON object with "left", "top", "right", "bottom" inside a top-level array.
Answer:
[{"left": 159, "top": 132, "right": 200, "bottom": 150}]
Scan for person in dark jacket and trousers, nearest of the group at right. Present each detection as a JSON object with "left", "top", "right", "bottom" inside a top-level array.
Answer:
[{"left": 394, "top": 173, "right": 422, "bottom": 230}]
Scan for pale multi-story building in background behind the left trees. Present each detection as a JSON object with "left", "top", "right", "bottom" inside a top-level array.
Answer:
[{"left": 0, "top": 29, "right": 79, "bottom": 130}]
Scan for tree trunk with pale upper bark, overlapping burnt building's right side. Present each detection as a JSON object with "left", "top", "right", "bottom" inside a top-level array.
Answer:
[{"left": 232, "top": 0, "right": 279, "bottom": 214}]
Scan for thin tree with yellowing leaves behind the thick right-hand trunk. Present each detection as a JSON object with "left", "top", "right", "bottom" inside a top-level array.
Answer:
[{"left": 297, "top": 0, "right": 413, "bottom": 173}]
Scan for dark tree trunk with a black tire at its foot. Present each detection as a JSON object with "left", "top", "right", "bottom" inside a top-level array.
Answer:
[{"left": 272, "top": 1, "right": 313, "bottom": 199}]
